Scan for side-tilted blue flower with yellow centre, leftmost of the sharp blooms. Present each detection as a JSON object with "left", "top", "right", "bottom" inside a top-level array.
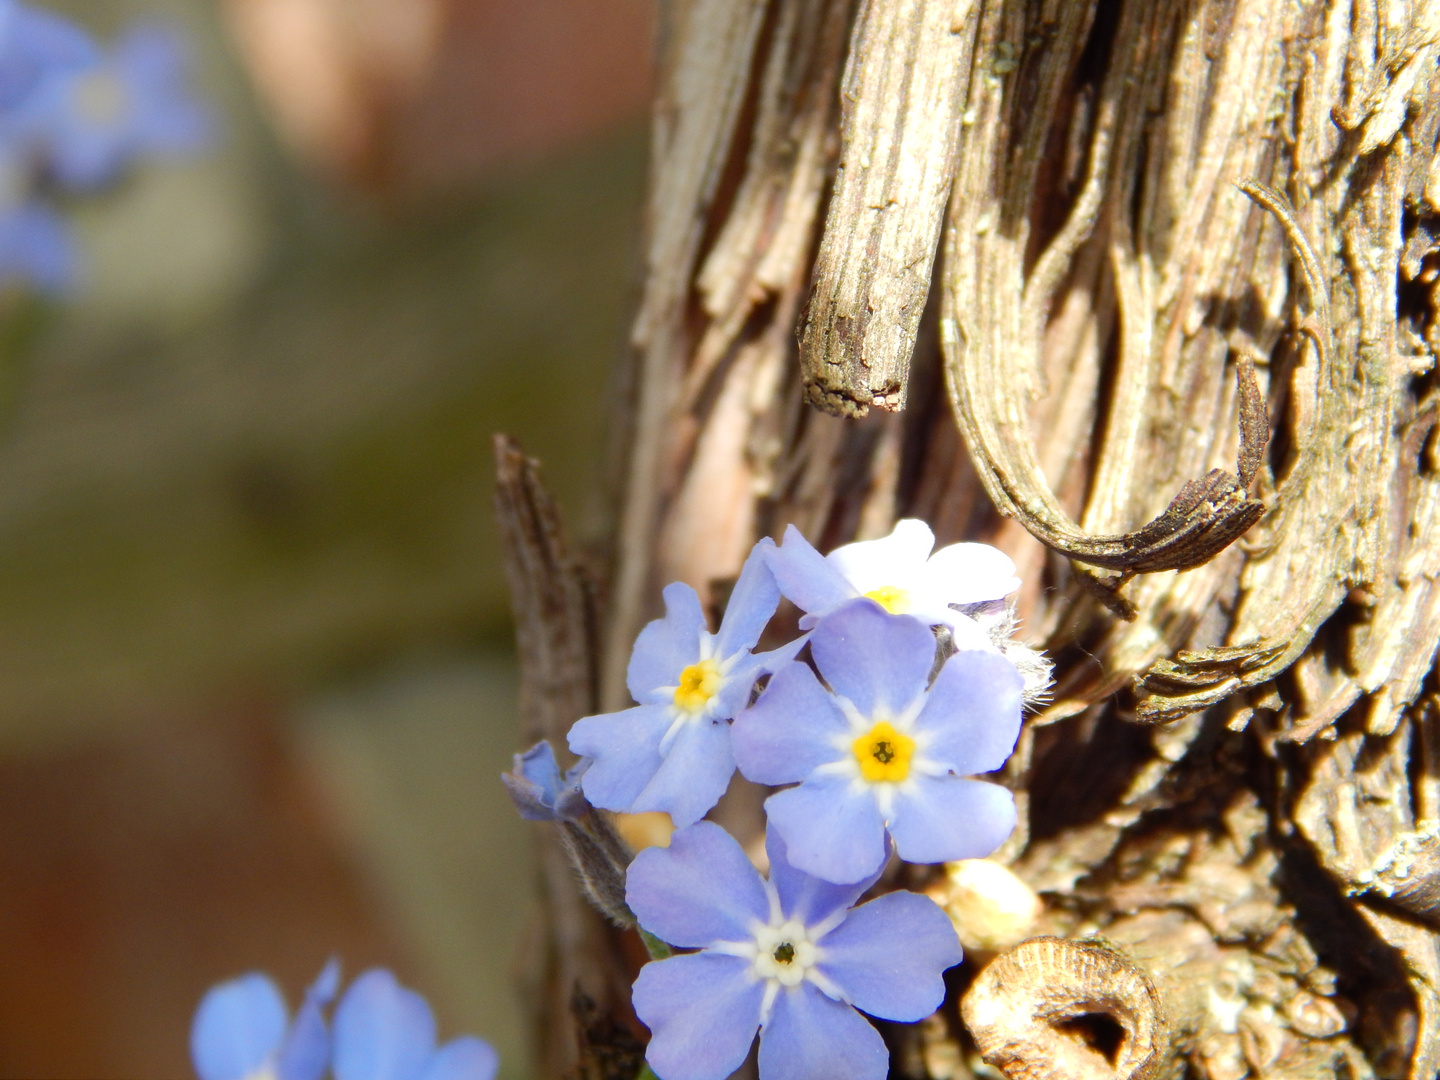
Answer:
[{"left": 570, "top": 540, "right": 805, "bottom": 827}]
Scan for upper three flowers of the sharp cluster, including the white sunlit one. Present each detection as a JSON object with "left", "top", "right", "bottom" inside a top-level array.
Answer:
[{"left": 570, "top": 520, "right": 1024, "bottom": 883}]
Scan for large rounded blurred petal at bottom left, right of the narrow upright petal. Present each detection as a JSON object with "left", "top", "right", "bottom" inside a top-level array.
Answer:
[{"left": 333, "top": 968, "right": 435, "bottom": 1080}]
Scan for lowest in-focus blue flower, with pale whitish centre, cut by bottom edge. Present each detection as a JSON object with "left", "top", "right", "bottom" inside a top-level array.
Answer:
[{"left": 626, "top": 822, "right": 960, "bottom": 1080}]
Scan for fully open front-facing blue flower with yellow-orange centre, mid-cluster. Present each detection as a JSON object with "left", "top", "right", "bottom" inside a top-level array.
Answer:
[{"left": 733, "top": 599, "right": 1024, "bottom": 881}]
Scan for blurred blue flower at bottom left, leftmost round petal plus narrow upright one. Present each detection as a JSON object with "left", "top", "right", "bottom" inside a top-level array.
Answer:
[{"left": 190, "top": 960, "right": 340, "bottom": 1080}]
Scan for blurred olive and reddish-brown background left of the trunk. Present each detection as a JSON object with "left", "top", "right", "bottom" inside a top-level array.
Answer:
[{"left": 0, "top": 0, "right": 652, "bottom": 1080}]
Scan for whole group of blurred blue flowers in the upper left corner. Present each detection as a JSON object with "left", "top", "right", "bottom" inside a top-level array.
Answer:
[{"left": 0, "top": 0, "right": 212, "bottom": 292}]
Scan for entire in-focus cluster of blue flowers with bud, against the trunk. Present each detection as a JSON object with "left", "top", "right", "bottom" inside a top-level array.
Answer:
[{"left": 507, "top": 520, "right": 1048, "bottom": 1080}]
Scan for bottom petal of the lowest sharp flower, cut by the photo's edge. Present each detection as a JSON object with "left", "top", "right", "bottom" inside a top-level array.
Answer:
[{"left": 760, "top": 982, "right": 890, "bottom": 1080}]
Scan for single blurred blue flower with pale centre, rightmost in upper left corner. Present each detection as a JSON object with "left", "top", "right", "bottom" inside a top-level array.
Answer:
[{"left": 17, "top": 23, "right": 213, "bottom": 192}]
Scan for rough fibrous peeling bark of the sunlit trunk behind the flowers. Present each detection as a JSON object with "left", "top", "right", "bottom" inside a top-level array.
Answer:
[{"left": 504, "top": 0, "right": 1440, "bottom": 1080}]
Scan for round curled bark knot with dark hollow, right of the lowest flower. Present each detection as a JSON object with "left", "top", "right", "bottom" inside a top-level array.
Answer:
[{"left": 960, "top": 937, "right": 1169, "bottom": 1080}]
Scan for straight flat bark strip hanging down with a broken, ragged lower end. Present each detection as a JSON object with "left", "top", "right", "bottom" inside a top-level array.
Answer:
[{"left": 801, "top": 0, "right": 975, "bottom": 416}]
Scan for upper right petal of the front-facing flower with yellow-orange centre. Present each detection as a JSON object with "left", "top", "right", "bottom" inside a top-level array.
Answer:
[{"left": 914, "top": 652, "right": 1025, "bottom": 776}]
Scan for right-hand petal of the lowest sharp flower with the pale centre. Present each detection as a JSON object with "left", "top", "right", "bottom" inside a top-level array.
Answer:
[{"left": 819, "top": 893, "right": 960, "bottom": 1022}]
